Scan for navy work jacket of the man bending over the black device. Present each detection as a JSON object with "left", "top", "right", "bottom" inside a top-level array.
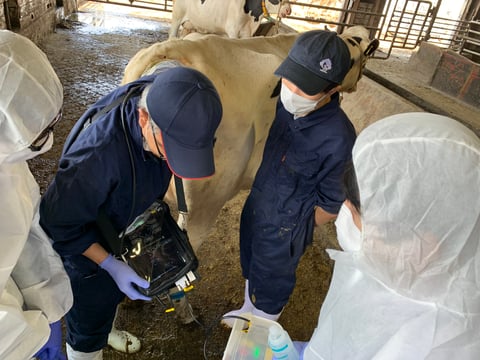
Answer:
[{"left": 40, "top": 75, "right": 172, "bottom": 256}]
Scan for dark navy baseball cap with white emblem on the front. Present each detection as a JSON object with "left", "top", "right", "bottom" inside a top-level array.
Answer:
[{"left": 275, "top": 30, "right": 351, "bottom": 95}]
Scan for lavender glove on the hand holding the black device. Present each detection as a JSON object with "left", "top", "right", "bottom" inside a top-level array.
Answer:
[{"left": 99, "top": 255, "right": 152, "bottom": 300}]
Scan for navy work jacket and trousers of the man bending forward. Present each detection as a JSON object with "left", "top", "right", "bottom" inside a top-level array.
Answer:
[{"left": 40, "top": 75, "right": 172, "bottom": 352}]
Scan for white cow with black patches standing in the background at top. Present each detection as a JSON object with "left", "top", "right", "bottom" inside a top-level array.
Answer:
[{"left": 169, "top": 0, "right": 291, "bottom": 39}]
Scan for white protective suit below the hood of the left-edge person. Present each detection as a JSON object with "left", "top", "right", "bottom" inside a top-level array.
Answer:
[{"left": 0, "top": 162, "right": 72, "bottom": 360}]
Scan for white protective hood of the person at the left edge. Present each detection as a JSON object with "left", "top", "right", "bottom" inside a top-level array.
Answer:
[{"left": 0, "top": 30, "right": 63, "bottom": 164}]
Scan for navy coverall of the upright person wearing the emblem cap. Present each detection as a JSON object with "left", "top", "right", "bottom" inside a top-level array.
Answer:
[{"left": 240, "top": 94, "right": 356, "bottom": 314}]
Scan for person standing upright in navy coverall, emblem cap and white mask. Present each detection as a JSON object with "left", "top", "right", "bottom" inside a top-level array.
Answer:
[{"left": 224, "top": 30, "right": 356, "bottom": 326}]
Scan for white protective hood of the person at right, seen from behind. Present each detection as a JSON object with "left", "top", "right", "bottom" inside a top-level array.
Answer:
[{"left": 353, "top": 113, "right": 480, "bottom": 314}]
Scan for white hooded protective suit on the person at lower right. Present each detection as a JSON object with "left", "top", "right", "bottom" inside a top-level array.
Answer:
[{"left": 304, "top": 113, "right": 480, "bottom": 360}]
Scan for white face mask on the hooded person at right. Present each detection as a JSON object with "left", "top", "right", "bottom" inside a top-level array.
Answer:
[{"left": 335, "top": 203, "right": 362, "bottom": 251}]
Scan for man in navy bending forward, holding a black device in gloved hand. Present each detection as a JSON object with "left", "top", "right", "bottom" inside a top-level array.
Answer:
[{"left": 40, "top": 65, "right": 222, "bottom": 360}]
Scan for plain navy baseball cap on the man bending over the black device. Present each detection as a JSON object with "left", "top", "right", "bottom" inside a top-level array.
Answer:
[{"left": 146, "top": 66, "right": 222, "bottom": 179}]
